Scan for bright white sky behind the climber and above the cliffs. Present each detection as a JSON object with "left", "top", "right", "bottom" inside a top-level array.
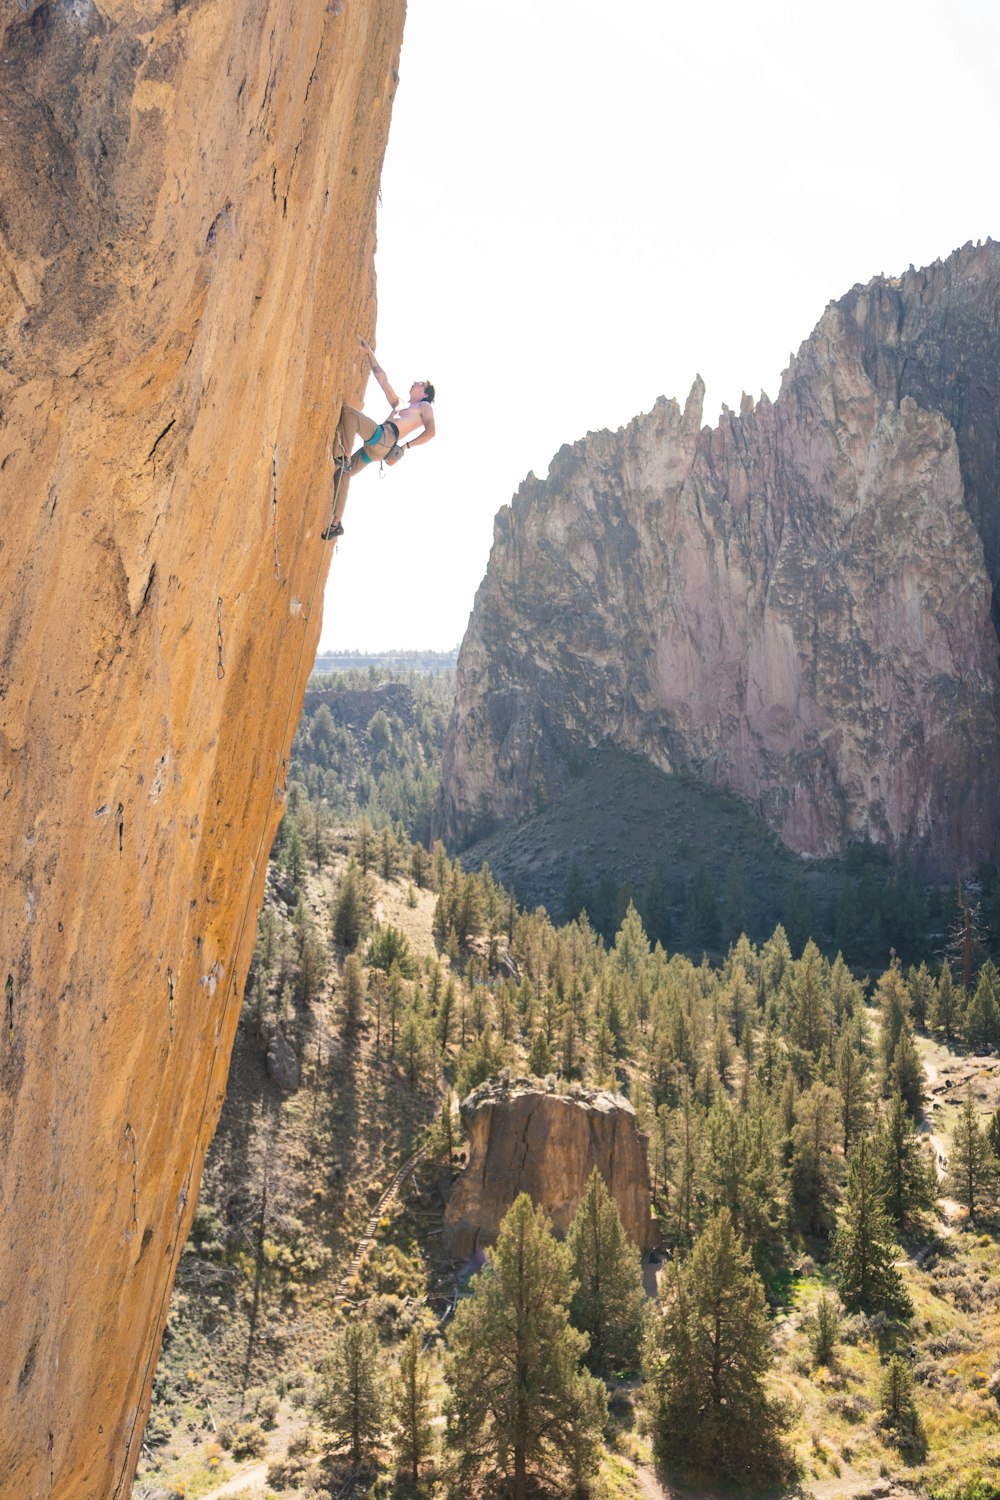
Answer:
[{"left": 321, "top": 0, "right": 1000, "bottom": 650}]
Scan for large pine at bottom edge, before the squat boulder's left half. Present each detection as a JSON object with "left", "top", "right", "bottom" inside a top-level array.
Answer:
[{"left": 445, "top": 1193, "right": 606, "bottom": 1500}]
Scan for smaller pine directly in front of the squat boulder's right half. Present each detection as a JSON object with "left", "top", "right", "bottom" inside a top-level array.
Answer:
[{"left": 567, "top": 1167, "right": 645, "bottom": 1376}]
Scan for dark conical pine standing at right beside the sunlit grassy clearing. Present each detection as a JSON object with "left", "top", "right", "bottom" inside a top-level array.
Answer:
[{"left": 834, "top": 1136, "right": 913, "bottom": 1317}]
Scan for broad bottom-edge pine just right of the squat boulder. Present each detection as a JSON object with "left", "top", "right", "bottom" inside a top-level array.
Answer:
[{"left": 646, "top": 1209, "right": 781, "bottom": 1484}]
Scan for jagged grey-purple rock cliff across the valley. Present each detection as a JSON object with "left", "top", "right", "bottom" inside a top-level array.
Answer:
[{"left": 439, "top": 243, "right": 1000, "bottom": 872}]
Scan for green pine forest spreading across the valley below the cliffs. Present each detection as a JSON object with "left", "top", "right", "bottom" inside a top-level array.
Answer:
[{"left": 138, "top": 672, "right": 1000, "bottom": 1500}]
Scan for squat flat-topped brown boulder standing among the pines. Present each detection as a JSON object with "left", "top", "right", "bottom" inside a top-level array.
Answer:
[{"left": 444, "top": 1079, "right": 655, "bottom": 1260}]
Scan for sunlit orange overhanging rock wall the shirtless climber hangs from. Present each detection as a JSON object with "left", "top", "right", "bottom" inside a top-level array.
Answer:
[{"left": 0, "top": 0, "right": 405, "bottom": 1500}]
